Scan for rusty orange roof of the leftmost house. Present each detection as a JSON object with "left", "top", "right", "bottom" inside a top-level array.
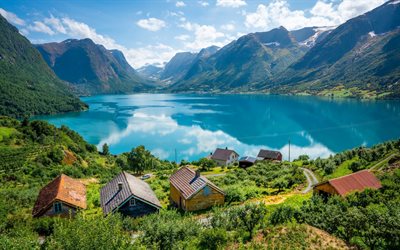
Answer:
[{"left": 32, "top": 174, "right": 86, "bottom": 216}]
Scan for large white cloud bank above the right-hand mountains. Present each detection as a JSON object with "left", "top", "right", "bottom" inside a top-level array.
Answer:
[{"left": 244, "top": 0, "right": 384, "bottom": 30}]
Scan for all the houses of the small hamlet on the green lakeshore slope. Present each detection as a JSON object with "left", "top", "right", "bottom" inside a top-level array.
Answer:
[{"left": 32, "top": 148, "right": 382, "bottom": 218}]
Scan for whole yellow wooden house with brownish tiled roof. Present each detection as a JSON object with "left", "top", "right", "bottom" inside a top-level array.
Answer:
[{"left": 169, "top": 167, "right": 225, "bottom": 211}]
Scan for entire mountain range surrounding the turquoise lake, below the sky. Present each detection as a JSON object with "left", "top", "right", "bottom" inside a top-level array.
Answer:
[{"left": 0, "top": 0, "right": 400, "bottom": 117}]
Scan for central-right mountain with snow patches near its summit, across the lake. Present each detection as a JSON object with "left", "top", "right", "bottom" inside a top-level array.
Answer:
[{"left": 170, "top": 27, "right": 308, "bottom": 92}]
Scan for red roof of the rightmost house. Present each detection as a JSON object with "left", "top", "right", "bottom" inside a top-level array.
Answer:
[{"left": 317, "top": 170, "right": 382, "bottom": 196}]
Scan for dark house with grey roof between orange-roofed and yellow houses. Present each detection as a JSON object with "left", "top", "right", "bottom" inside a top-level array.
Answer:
[{"left": 100, "top": 172, "right": 161, "bottom": 217}]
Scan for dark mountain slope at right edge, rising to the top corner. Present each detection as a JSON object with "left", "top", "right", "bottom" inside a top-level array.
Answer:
[{"left": 272, "top": 0, "right": 400, "bottom": 96}]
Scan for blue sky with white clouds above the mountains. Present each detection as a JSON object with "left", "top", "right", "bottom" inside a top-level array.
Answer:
[{"left": 0, "top": 0, "right": 385, "bottom": 68}]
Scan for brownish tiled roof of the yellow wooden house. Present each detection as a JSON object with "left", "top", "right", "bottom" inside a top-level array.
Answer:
[{"left": 169, "top": 167, "right": 224, "bottom": 199}]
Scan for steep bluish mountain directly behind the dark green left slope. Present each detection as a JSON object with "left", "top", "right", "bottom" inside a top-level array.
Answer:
[{"left": 36, "top": 38, "right": 148, "bottom": 94}]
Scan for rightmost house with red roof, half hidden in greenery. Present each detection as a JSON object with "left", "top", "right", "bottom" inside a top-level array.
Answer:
[{"left": 314, "top": 170, "right": 382, "bottom": 197}]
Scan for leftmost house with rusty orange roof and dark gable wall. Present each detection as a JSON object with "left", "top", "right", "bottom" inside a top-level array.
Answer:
[{"left": 32, "top": 174, "right": 86, "bottom": 218}]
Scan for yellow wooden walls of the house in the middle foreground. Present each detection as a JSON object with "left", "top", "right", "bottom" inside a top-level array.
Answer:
[{"left": 185, "top": 186, "right": 225, "bottom": 211}]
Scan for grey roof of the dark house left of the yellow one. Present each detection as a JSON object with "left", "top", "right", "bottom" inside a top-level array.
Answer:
[{"left": 100, "top": 172, "right": 161, "bottom": 214}]
